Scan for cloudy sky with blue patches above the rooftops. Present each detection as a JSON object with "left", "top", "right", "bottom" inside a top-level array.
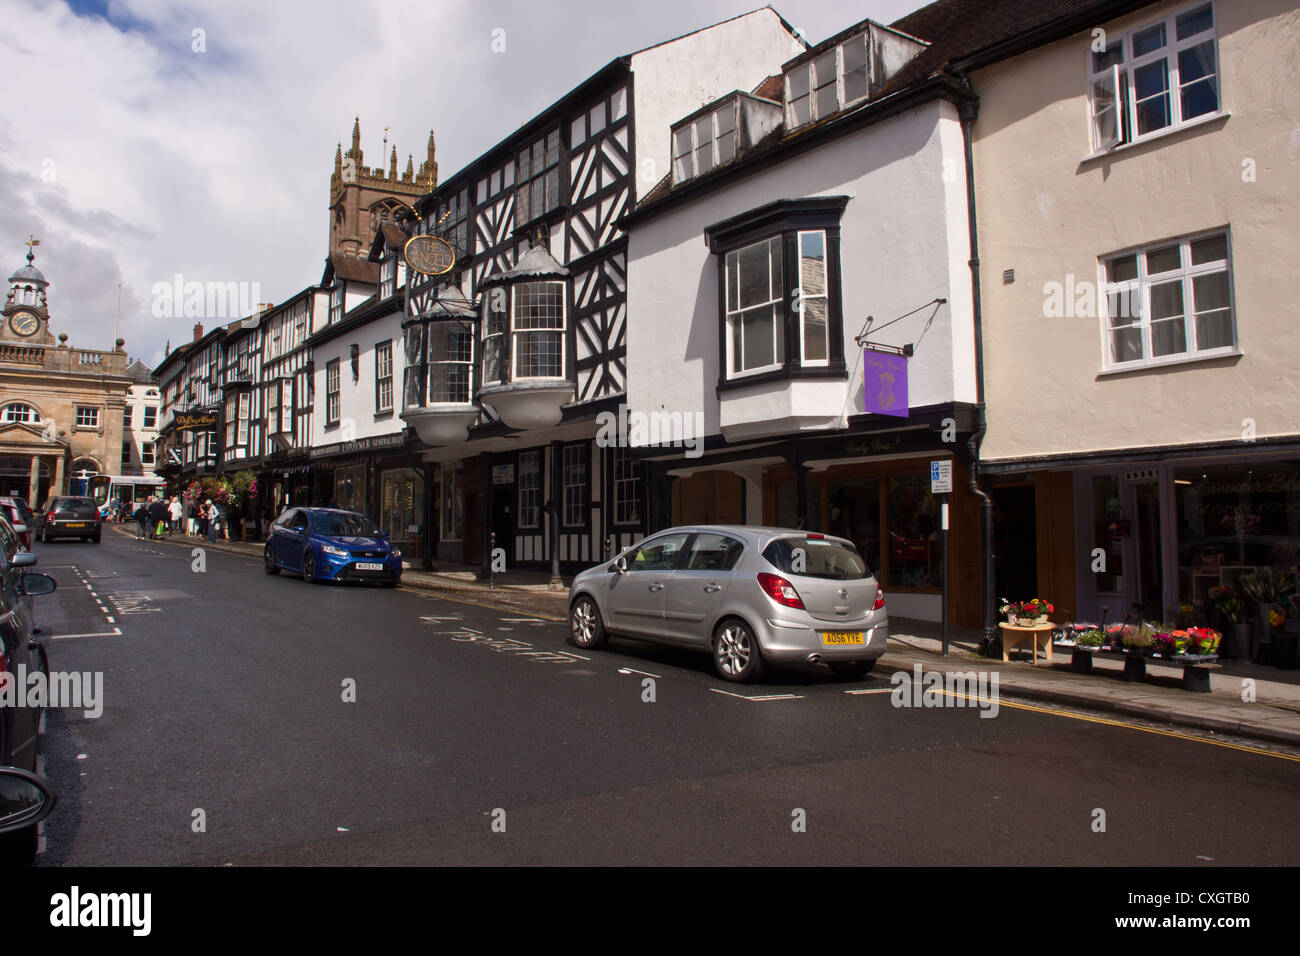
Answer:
[{"left": 0, "top": 0, "right": 924, "bottom": 365}]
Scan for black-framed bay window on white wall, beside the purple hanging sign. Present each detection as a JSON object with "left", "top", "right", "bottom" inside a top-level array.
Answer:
[{"left": 705, "top": 196, "right": 848, "bottom": 389}]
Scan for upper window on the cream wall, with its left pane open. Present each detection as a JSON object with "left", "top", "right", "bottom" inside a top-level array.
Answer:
[{"left": 1088, "top": 3, "right": 1223, "bottom": 152}]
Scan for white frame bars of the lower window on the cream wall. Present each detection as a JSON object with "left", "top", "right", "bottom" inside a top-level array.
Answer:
[{"left": 1097, "top": 229, "right": 1239, "bottom": 372}]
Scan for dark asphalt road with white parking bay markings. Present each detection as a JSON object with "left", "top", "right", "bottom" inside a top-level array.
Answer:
[{"left": 17, "top": 529, "right": 1300, "bottom": 866}]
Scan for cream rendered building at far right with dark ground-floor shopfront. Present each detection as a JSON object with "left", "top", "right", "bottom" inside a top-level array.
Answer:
[{"left": 954, "top": 0, "right": 1300, "bottom": 634}]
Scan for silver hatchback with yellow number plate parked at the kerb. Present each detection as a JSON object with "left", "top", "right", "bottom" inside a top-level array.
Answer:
[{"left": 569, "top": 525, "right": 889, "bottom": 682}]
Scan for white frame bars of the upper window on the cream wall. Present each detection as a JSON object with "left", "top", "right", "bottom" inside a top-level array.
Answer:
[{"left": 1086, "top": 0, "right": 1226, "bottom": 153}]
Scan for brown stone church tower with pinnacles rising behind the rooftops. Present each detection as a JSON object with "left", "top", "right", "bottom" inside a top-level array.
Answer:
[{"left": 329, "top": 117, "right": 438, "bottom": 259}]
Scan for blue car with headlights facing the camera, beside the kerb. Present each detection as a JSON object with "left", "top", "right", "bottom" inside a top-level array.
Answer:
[{"left": 263, "top": 507, "right": 402, "bottom": 588}]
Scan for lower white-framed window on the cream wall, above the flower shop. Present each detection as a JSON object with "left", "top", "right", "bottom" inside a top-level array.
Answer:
[{"left": 1102, "top": 232, "right": 1236, "bottom": 368}]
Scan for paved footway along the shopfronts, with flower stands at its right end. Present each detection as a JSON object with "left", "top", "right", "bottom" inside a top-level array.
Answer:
[{"left": 109, "top": 525, "right": 1300, "bottom": 747}]
